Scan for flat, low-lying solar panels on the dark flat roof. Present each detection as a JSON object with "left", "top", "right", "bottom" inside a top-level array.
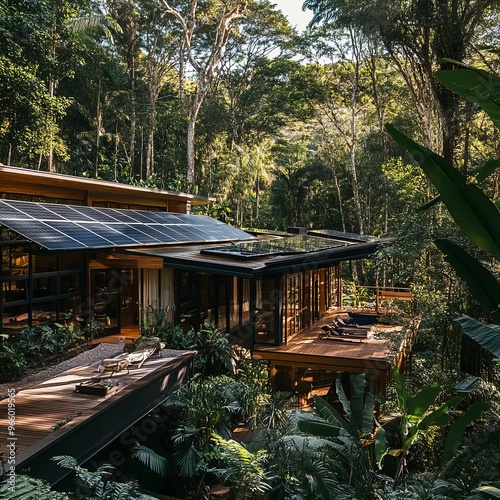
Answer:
[{"left": 201, "top": 235, "right": 352, "bottom": 259}]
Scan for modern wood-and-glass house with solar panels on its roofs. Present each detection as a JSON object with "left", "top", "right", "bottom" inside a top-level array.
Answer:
[{"left": 0, "top": 166, "right": 396, "bottom": 396}]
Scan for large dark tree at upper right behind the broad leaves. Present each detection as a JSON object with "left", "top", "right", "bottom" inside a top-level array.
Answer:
[{"left": 303, "top": 0, "right": 500, "bottom": 161}]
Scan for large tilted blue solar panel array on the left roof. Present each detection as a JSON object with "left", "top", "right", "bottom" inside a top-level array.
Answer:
[{"left": 0, "top": 200, "right": 254, "bottom": 250}]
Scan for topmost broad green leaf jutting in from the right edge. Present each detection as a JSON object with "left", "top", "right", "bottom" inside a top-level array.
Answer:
[{"left": 435, "top": 67, "right": 500, "bottom": 128}]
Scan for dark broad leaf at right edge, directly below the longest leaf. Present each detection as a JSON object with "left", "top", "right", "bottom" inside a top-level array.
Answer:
[{"left": 435, "top": 240, "right": 500, "bottom": 323}]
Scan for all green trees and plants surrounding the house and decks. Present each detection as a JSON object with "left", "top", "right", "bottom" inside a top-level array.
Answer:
[{"left": 0, "top": 0, "right": 500, "bottom": 500}]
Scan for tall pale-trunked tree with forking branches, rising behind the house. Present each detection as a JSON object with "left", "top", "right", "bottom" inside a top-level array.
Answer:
[{"left": 162, "top": 0, "right": 248, "bottom": 186}]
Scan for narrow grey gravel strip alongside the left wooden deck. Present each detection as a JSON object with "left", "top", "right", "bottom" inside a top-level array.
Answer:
[{"left": 0, "top": 344, "right": 123, "bottom": 399}]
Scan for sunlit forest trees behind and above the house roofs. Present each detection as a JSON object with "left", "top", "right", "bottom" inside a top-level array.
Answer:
[{"left": 0, "top": 0, "right": 499, "bottom": 234}]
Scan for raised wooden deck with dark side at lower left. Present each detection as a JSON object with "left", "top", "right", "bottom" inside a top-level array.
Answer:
[{"left": 0, "top": 350, "right": 194, "bottom": 483}]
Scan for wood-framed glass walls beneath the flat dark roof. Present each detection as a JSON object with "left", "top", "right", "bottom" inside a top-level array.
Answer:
[{"left": 175, "top": 266, "right": 340, "bottom": 345}]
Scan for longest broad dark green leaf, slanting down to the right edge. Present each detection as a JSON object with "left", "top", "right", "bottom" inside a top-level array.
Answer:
[{"left": 386, "top": 124, "right": 500, "bottom": 259}]
